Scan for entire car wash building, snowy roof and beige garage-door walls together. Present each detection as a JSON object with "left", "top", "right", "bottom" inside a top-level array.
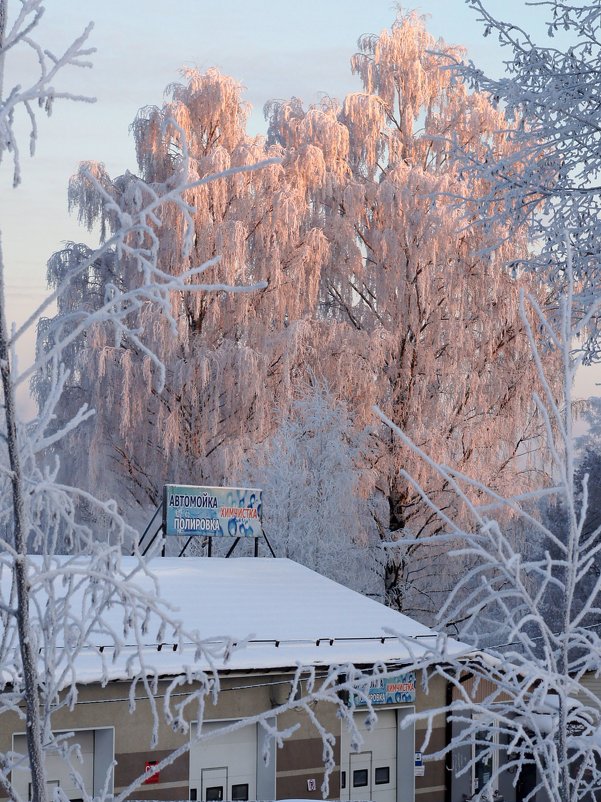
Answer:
[{"left": 0, "top": 558, "right": 464, "bottom": 802}]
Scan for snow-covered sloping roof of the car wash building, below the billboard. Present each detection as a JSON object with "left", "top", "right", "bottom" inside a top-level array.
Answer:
[{"left": 3, "top": 557, "right": 468, "bottom": 683}]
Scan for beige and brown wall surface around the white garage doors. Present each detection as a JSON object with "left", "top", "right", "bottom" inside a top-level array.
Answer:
[{"left": 0, "top": 674, "right": 445, "bottom": 802}]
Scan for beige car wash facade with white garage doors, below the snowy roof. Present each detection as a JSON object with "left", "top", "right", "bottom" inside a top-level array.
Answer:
[{"left": 0, "top": 672, "right": 446, "bottom": 802}]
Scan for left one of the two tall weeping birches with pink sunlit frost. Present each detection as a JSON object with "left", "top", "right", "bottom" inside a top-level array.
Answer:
[{"left": 38, "top": 65, "right": 367, "bottom": 514}]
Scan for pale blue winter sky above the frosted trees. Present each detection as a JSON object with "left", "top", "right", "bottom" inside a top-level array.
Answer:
[{"left": 0, "top": 0, "right": 595, "bottom": 411}]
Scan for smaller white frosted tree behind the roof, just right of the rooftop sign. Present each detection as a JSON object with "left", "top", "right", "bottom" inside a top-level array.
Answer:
[{"left": 243, "top": 380, "right": 382, "bottom": 593}]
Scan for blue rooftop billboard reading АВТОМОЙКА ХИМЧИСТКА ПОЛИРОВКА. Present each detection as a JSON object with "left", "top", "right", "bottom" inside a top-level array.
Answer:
[{"left": 163, "top": 485, "right": 263, "bottom": 537}]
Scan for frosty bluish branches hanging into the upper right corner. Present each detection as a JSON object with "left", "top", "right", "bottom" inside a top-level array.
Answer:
[{"left": 450, "top": 0, "right": 601, "bottom": 354}]
